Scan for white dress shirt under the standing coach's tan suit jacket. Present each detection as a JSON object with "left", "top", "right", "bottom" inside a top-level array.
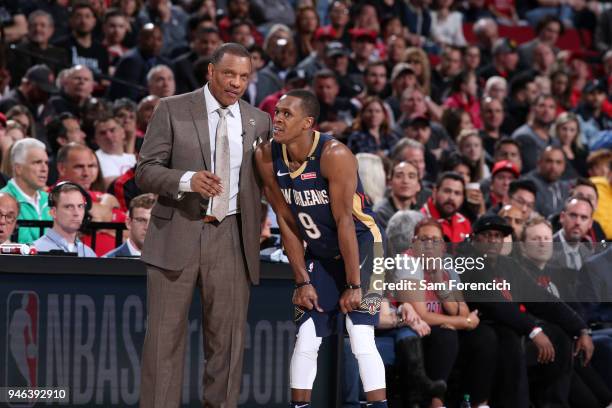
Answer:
[{"left": 179, "top": 84, "right": 242, "bottom": 215}]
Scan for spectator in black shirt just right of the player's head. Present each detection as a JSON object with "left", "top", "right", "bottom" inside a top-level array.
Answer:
[{"left": 312, "top": 69, "right": 358, "bottom": 139}]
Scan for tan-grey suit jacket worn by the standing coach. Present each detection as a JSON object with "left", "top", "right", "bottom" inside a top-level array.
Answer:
[{"left": 136, "top": 88, "right": 272, "bottom": 284}]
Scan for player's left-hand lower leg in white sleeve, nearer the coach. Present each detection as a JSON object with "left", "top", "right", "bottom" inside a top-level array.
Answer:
[{"left": 289, "top": 318, "right": 322, "bottom": 408}]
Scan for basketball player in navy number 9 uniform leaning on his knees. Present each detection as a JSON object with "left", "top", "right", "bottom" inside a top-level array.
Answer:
[{"left": 255, "top": 90, "right": 387, "bottom": 408}]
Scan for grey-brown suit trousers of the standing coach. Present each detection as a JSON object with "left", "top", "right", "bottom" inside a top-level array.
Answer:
[{"left": 140, "top": 216, "right": 249, "bottom": 408}]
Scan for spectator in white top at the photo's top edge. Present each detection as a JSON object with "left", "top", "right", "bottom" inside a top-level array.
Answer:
[{"left": 430, "top": 0, "right": 467, "bottom": 47}]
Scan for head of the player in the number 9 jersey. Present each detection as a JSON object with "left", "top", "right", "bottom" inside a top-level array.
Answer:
[{"left": 273, "top": 89, "right": 321, "bottom": 143}]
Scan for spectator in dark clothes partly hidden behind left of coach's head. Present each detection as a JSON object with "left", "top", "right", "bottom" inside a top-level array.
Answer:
[{"left": 172, "top": 27, "right": 221, "bottom": 95}]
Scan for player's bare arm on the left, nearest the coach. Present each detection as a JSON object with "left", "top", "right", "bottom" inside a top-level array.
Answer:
[{"left": 255, "top": 142, "right": 322, "bottom": 311}]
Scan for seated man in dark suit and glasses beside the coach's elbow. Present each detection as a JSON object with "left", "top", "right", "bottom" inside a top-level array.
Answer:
[{"left": 104, "top": 193, "right": 155, "bottom": 258}]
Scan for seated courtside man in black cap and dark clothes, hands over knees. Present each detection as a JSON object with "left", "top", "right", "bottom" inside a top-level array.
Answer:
[{"left": 462, "top": 215, "right": 593, "bottom": 407}]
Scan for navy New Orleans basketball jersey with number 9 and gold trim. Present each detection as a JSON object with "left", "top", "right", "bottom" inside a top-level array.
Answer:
[{"left": 272, "top": 131, "right": 382, "bottom": 259}]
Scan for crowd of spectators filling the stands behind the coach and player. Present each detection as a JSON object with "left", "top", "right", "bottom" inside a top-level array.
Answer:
[{"left": 0, "top": 0, "right": 612, "bottom": 408}]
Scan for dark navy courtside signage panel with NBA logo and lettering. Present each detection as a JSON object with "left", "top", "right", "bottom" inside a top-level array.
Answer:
[{"left": 0, "top": 262, "right": 295, "bottom": 407}]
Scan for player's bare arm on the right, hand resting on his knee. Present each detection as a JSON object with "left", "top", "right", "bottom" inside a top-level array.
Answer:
[{"left": 321, "top": 141, "right": 361, "bottom": 313}]
